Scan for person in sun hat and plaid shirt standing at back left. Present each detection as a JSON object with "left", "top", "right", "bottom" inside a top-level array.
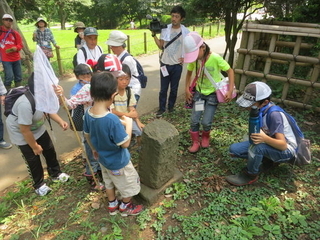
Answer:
[{"left": 32, "top": 18, "right": 60, "bottom": 58}]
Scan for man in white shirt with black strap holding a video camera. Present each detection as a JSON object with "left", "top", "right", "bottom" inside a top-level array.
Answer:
[{"left": 152, "top": 6, "right": 189, "bottom": 117}]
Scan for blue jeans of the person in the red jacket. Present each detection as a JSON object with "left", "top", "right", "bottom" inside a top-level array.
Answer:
[{"left": 2, "top": 60, "right": 22, "bottom": 87}]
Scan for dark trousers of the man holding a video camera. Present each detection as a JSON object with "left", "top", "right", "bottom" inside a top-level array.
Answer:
[{"left": 159, "top": 64, "right": 182, "bottom": 111}]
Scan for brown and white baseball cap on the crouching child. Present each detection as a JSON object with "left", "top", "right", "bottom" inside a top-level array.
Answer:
[{"left": 236, "top": 81, "right": 272, "bottom": 108}]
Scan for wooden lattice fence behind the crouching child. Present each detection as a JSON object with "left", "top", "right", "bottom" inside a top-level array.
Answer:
[{"left": 235, "top": 21, "right": 320, "bottom": 111}]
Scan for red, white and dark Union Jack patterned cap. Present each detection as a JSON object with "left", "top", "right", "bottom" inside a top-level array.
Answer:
[{"left": 96, "top": 54, "right": 126, "bottom": 77}]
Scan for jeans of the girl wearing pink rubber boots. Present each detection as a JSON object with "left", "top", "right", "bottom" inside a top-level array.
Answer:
[{"left": 190, "top": 91, "right": 218, "bottom": 132}]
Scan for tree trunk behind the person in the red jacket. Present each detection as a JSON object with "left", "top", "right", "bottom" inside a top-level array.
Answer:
[{"left": 0, "top": 0, "right": 33, "bottom": 74}]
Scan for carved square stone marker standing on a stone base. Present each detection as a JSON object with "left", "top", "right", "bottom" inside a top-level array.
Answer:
[{"left": 138, "top": 119, "right": 182, "bottom": 204}]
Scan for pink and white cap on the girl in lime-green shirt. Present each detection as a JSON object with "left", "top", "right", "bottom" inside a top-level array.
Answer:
[{"left": 183, "top": 32, "right": 203, "bottom": 63}]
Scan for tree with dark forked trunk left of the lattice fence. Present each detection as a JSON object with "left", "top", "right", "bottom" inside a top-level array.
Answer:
[{"left": 188, "top": 0, "right": 264, "bottom": 66}]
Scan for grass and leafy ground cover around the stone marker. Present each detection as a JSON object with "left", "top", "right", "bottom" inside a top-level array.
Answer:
[{"left": 0, "top": 103, "right": 320, "bottom": 240}]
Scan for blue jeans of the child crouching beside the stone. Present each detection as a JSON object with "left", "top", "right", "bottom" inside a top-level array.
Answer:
[{"left": 229, "top": 141, "right": 294, "bottom": 174}]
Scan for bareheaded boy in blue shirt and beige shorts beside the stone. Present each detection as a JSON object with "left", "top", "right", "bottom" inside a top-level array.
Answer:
[{"left": 83, "top": 72, "right": 143, "bottom": 216}]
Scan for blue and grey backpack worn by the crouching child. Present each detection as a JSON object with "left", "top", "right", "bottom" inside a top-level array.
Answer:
[{"left": 266, "top": 106, "right": 311, "bottom": 166}]
